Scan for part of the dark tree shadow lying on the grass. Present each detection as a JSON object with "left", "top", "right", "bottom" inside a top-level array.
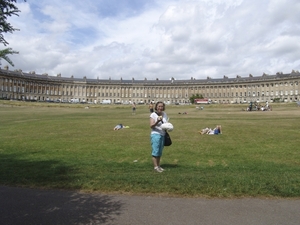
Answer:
[{"left": 0, "top": 153, "right": 77, "bottom": 188}]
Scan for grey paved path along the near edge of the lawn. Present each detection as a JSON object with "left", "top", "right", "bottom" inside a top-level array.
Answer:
[{"left": 0, "top": 186, "right": 300, "bottom": 225}]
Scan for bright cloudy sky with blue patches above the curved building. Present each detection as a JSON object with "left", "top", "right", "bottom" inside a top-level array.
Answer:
[{"left": 1, "top": 0, "right": 300, "bottom": 80}]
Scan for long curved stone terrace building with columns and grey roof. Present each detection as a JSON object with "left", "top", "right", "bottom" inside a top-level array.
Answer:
[{"left": 0, "top": 67, "right": 300, "bottom": 104}]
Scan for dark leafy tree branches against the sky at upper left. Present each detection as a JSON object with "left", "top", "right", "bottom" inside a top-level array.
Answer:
[{"left": 0, "top": 0, "right": 26, "bottom": 66}]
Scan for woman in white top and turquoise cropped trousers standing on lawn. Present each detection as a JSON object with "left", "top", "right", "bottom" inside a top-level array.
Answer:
[{"left": 150, "top": 102, "right": 168, "bottom": 173}]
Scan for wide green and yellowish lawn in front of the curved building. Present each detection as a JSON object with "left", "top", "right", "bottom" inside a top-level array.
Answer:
[{"left": 0, "top": 101, "right": 300, "bottom": 197}]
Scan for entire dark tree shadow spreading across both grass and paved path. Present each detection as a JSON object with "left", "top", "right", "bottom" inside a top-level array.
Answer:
[{"left": 0, "top": 154, "right": 123, "bottom": 225}]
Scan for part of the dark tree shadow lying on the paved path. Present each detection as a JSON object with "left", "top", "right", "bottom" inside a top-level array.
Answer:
[{"left": 0, "top": 186, "right": 124, "bottom": 225}]
